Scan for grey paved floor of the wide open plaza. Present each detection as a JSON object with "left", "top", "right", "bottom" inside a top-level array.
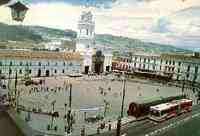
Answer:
[{"left": 6, "top": 76, "right": 198, "bottom": 136}]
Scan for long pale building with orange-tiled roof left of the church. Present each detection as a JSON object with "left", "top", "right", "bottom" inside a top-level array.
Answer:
[{"left": 0, "top": 50, "right": 82, "bottom": 78}]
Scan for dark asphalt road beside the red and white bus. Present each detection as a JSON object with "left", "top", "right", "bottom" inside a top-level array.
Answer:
[{"left": 90, "top": 105, "right": 200, "bottom": 136}]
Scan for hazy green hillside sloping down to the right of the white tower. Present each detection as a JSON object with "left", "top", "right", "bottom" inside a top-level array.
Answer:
[{"left": 96, "top": 34, "right": 189, "bottom": 52}]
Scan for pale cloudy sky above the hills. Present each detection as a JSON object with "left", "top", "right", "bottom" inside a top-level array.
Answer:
[{"left": 0, "top": 0, "right": 200, "bottom": 50}]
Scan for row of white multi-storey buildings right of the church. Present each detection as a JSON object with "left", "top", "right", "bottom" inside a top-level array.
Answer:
[{"left": 113, "top": 54, "right": 200, "bottom": 83}]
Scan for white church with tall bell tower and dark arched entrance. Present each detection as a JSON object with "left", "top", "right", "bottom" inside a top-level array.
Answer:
[{"left": 76, "top": 9, "right": 112, "bottom": 74}]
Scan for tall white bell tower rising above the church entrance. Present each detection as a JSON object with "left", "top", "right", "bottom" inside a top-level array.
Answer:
[{"left": 76, "top": 4, "right": 95, "bottom": 52}]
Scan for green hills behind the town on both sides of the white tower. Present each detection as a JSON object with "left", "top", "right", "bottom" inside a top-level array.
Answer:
[{"left": 0, "top": 23, "right": 192, "bottom": 52}]
